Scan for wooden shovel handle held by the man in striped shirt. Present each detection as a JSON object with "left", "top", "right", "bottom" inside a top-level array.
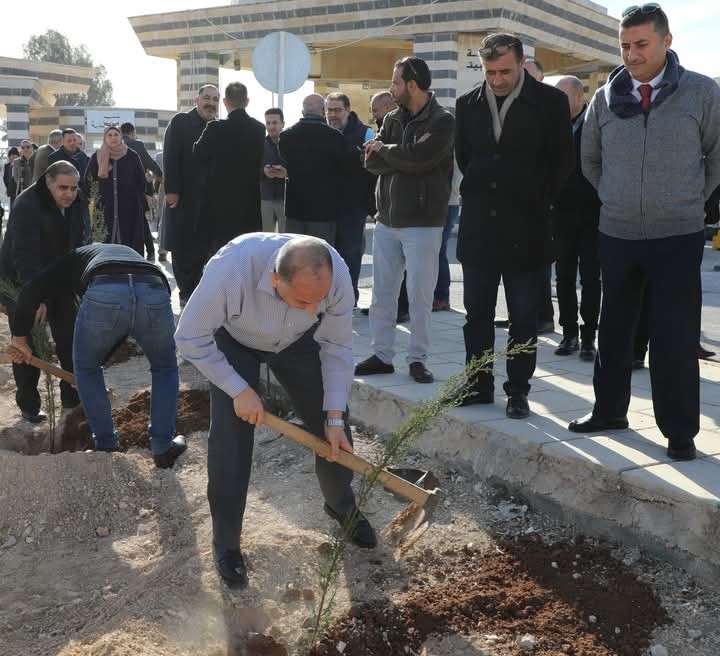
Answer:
[{"left": 264, "top": 411, "right": 432, "bottom": 506}]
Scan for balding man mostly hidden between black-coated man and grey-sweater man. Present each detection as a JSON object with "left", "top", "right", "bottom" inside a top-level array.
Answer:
[{"left": 554, "top": 75, "right": 600, "bottom": 362}]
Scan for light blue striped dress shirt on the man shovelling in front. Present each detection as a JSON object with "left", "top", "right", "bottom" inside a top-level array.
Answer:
[{"left": 175, "top": 232, "right": 355, "bottom": 411}]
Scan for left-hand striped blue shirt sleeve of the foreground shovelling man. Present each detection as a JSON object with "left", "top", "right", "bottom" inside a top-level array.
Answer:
[{"left": 175, "top": 261, "right": 248, "bottom": 398}]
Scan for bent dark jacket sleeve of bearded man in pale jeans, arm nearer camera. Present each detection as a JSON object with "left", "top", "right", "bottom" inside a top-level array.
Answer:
[{"left": 368, "top": 110, "right": 452, "bottom": 175}]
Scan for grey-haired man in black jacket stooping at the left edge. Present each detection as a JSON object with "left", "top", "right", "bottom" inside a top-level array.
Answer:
[{"left": 0, "top": 161, "right": 85, "bottom": 423}]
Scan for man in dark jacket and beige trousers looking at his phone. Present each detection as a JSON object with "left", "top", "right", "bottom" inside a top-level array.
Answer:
[{"left": 260, "top": 107, "right": 287, "bottom": 232}]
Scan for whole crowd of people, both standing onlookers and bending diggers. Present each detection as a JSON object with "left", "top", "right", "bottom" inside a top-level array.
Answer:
[{"left": 0, "top": 3, "right": 720, "bottom": 585}]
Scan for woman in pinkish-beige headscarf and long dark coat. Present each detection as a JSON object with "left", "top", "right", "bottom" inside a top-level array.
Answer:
[{"left": 86, "top": 126, "right": 145, "bottom": 255}]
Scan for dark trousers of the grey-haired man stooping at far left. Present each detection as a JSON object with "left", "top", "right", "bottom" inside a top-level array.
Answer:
[{"left": 7, "top": 296, "right": 80, "bottom": 415}]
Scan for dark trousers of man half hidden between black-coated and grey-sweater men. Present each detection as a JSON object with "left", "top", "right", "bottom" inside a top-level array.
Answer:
[{"left": 555, "top": 221, "right": 601, "bottom": 342}]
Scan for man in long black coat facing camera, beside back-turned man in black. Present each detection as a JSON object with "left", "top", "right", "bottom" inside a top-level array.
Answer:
[{"left": 163, "top": 84, "right": 220, "bottom": 306}]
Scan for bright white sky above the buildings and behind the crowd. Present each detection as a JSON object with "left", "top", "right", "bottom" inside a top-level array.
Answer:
[{"left": 0, "top": 0, "right": 720, "bottom": 122}]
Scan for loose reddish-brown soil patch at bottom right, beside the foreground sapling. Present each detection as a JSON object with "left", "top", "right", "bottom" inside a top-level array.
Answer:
[{"left": 310, "top": 535, "right": 668, "bottom": 656}]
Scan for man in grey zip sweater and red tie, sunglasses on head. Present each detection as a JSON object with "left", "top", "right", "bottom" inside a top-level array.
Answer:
[{"left": 569, "top": 3, "right": 720, "bottom": 460}]
